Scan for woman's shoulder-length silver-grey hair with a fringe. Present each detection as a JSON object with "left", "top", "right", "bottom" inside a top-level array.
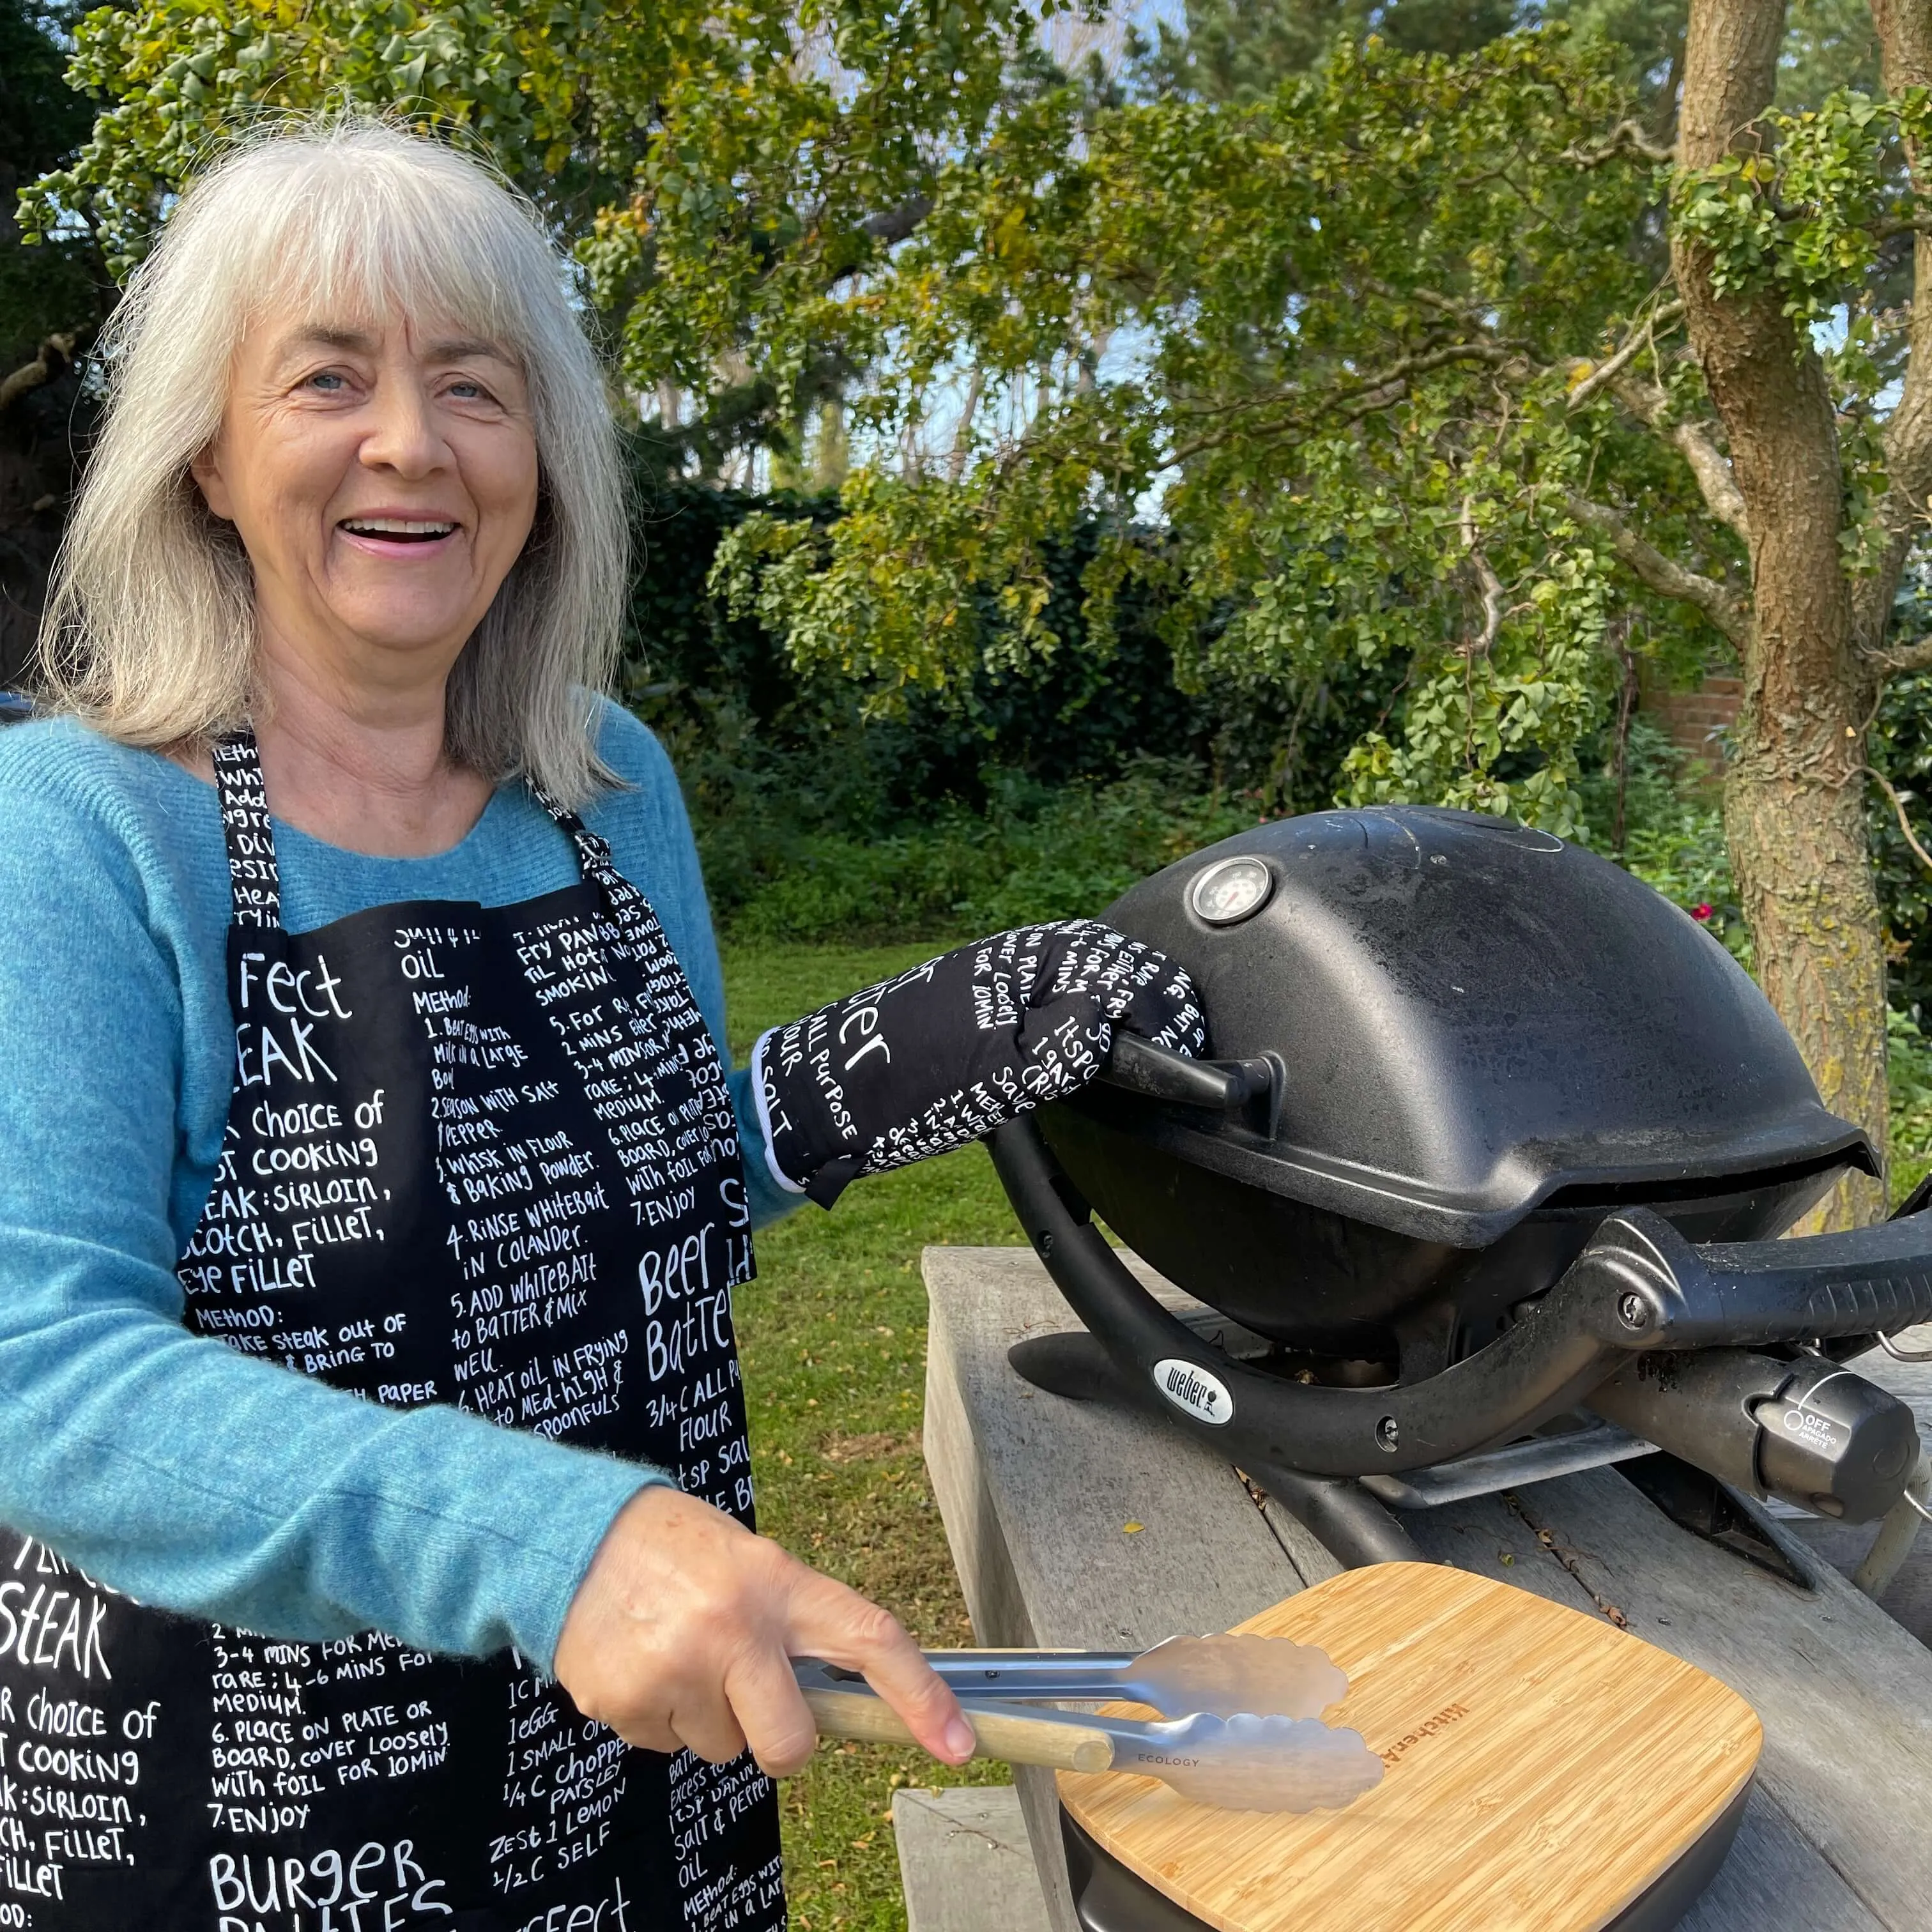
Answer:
[{"left": 41, "top": 116, "right": 628, "bottom": 806}]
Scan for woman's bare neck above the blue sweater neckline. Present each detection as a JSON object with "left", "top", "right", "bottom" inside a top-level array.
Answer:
[{"left": 183, "top": 640, "right": 491, "bottom": 858}]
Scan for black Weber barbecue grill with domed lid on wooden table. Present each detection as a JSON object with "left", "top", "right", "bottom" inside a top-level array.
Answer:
[{"left": 993, "top": 806, "right": 1932, "bottom": 1563}]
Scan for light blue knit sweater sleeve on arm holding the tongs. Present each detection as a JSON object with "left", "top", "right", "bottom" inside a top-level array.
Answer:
[{"left": 0, "top": 792, "right": 666, "bottom": 1667}]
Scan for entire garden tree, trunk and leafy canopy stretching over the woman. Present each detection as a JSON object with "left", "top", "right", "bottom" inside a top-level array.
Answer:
[{"left": 29, "top": 0, "right": 1932, "bottom": 1217}]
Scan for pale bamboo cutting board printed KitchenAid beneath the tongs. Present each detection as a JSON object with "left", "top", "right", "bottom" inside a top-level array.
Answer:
[{"left": 1059, "top": 1563, "right": 1762, "bottom": 1932}]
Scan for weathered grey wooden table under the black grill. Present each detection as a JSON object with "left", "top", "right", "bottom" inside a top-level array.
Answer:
[{"left": 925, "top": 1248, "right": 1932, "bottom": 1932}]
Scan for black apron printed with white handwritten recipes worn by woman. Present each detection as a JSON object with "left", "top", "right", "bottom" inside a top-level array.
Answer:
[{"left": 0, "top": 736, "right": 785, "bottom": 1932}]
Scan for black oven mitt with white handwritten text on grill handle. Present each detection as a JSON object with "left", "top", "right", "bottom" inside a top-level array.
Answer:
[{"left": 751, "top": 919, "right": 1208, "bottom": 1208}]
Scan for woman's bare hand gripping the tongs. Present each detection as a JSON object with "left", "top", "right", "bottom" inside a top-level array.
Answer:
[{"left": 555, "top": 1485, "right": 974, "bottom": 1777}]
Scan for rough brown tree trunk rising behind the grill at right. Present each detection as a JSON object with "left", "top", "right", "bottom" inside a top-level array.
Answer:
[{"left": 1671, "top": 0, "right": 1932, "bottom": 1209}]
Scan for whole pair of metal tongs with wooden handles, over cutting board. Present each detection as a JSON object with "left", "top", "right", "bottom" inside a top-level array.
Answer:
[{"left": 792, "top": 1636, "right": 1381, "bottom": 1813}]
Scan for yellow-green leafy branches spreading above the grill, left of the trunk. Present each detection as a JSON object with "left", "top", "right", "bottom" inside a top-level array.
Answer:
[{"left": 703, "top": 33, "right": 1735, "bottom": 827}]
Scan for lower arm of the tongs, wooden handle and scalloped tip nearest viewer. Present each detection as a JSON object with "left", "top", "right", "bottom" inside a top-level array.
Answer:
[{"left": 792, "top": 1658, "right": 1381, "bottom": 1813}]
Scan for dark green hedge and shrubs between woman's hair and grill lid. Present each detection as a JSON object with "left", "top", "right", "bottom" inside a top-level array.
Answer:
[{"left": 626, "top": 457, "right": 1383, "bottom": 939}]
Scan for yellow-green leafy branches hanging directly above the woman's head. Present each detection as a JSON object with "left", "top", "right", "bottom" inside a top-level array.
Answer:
[{"left": 21, "top": 0, "right": 1089, "bottom": 483}]
